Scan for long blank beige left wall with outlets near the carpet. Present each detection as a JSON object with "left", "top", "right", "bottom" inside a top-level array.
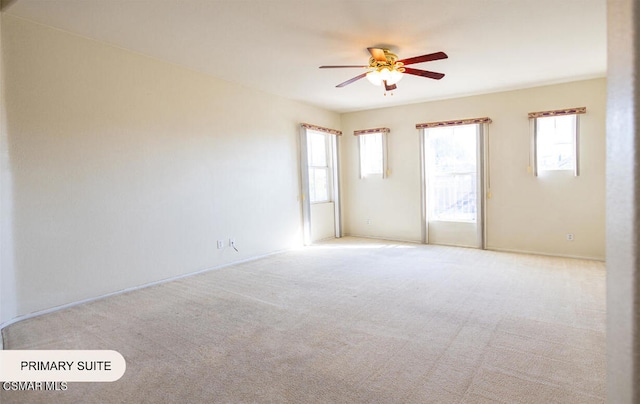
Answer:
[{"left": 0, "top": 15, "right": 340, "bottom": 323}]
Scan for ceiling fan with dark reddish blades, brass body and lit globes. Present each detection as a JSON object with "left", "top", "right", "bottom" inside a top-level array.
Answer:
[{"left": 320, "top": 48, "right": 448, "bottom": 91}]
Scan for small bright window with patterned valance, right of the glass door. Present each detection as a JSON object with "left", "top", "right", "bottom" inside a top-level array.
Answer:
[{"left": 529, "top": 108, "right": 586, "bottom": 175}]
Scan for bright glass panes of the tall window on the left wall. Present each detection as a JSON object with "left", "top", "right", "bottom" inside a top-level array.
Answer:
[{"left": 307, "top": 131, "right": 331, "bottom": 203}]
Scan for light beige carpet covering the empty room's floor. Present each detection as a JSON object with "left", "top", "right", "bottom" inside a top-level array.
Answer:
[{"left": 0, "top": 238, "right": 606, "bottom": 403}]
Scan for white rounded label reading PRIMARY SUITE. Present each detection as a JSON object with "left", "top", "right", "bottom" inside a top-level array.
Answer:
[{"left": 0, "top": 350, "right": 127, "bottom": 382}]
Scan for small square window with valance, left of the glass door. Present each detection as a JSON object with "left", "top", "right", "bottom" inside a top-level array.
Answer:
[{"left": 354, "top": 128, "right": 389, "bottom": 178}]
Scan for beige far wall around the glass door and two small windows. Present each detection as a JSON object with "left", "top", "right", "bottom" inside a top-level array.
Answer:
[{"left": 341, "top": 78, "right": 606, "bottom": 259}]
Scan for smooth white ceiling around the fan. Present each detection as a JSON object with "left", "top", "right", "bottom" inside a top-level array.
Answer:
[{"left": 5, "top": 0, "right": 606, "bottom": 112}]
